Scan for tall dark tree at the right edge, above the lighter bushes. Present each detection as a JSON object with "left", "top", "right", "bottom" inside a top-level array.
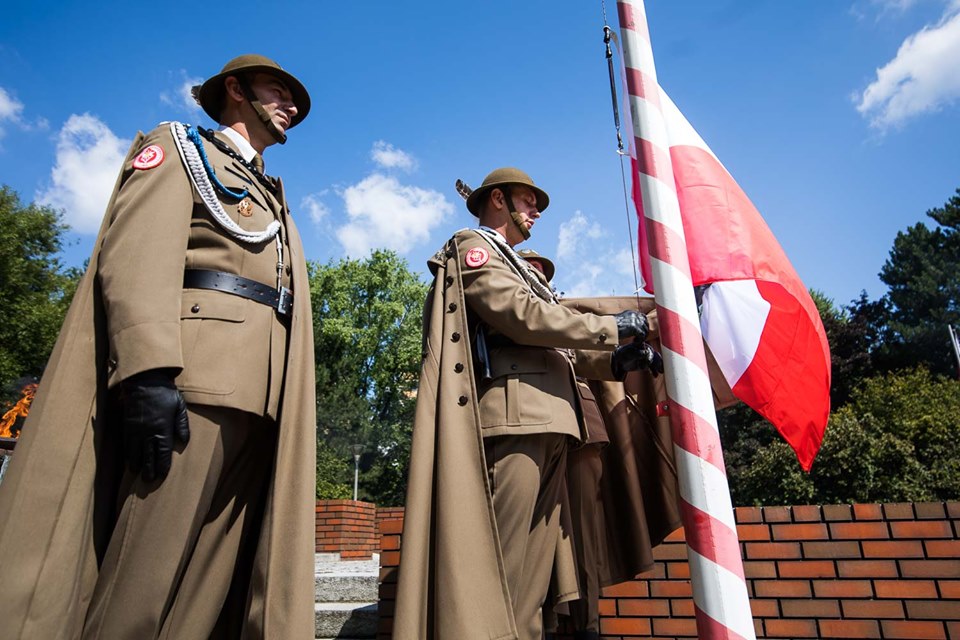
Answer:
[{"left": 873, "top": 189, "right": 960, "bottom": 375}]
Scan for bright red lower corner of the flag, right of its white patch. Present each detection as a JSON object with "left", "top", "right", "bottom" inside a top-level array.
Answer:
[{"left": 732, "top": 281, "right": 830, "bottom": 471}]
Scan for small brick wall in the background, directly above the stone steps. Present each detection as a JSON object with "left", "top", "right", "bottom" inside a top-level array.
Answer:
[{"left": 316, "top": 500, "right": 380, "bottom": 560}]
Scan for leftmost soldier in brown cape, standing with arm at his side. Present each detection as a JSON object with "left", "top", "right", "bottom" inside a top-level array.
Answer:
[{"left": 0, "top": 55, "right": 316, "bottom": 640}]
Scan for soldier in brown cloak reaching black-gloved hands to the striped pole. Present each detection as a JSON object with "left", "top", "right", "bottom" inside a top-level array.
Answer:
[{"left": 394, "top": 168, "right": 653, "bottom": 640}]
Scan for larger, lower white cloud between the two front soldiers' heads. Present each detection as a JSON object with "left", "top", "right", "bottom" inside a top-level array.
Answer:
[{"left": 336, "top": 173, "right": 454, "bottom": 257}]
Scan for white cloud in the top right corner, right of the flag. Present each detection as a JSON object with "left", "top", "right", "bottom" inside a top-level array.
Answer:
[{"left": 855, "top": 0, "right": 960, "bottom": 131}]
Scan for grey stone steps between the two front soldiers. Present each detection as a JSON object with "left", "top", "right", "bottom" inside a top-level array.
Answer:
[{"left": 314, "top": 553, "right": 380, "bottom": 640}]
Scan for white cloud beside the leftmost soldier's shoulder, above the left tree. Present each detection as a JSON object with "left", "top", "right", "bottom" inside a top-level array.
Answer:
[{"left": 37, "top": 113, "right": 130, "bottom": 233}]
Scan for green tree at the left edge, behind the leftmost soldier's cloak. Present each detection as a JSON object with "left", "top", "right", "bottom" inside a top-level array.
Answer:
[{"left": 0, "top": 186, "right": 81, "bottom": 403}]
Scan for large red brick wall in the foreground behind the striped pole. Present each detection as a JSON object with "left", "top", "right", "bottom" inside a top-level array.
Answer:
[{"left": 379, "top": 502, "right": 960, "bottom": 640}]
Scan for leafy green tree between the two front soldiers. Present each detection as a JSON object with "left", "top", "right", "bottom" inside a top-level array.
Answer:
[{"left": 310, "top": 251, "right": 427, "bottom": 505}]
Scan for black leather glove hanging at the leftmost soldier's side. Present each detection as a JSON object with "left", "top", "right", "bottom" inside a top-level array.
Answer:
[{"left": 120, "top": 370, "right": 190, "bottom": 482}]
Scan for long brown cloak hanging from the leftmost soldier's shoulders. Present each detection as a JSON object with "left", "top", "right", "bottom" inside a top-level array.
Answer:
[{"left": 0, "top": 127, "right": 316, "bottom": 640}]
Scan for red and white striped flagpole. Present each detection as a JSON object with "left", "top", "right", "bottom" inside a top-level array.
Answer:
[{"left": 617, "top": 0, "right": 756, "bottom": 640}]
